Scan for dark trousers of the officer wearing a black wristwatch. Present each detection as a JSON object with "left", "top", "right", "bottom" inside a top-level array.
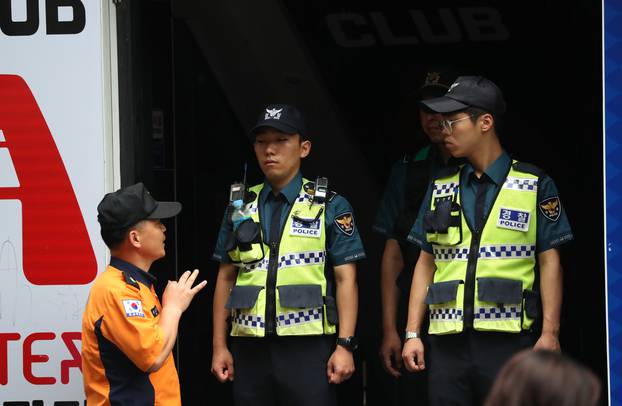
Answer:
[{"left": 231, "top": 336, "right": 337, "bottom": 406}]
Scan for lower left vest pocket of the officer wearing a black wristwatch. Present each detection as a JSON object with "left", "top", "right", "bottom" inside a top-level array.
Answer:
[{"left": 225, "top": 286, "right": 265, "bottom": 337}]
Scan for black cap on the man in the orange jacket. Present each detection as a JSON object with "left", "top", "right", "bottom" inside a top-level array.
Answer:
[{"left": 97, "top": 183, "right": 181, "bottom": 230}]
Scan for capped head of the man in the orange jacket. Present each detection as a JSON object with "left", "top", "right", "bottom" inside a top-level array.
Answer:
[{"left": 97, "top": 183, "right": 181, "bottom": 270}]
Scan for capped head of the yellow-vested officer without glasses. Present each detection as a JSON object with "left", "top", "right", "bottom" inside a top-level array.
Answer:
[{"left": 250, "top": 104, "right": 311, "bottom": 190}]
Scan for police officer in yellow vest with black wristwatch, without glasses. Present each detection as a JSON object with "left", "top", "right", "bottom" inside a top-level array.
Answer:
[{"left": 212, "top": 105, "right": 365, "bottom": 406}]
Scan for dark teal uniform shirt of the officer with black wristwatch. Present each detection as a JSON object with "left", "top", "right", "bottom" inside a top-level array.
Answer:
[{"left": 212, "top": 172, "right": 365, "bottom": 266}]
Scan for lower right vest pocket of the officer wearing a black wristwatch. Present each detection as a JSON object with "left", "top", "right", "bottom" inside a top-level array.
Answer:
[{"left": 276, "top": 285, "right": 324, "bottom": 336}]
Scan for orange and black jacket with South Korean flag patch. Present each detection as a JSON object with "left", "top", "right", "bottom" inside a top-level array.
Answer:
[{"left": 82, "top": 257, "right": 181, "bottom": 406}]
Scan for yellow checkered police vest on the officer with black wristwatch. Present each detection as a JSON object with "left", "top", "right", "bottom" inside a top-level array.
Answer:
[{"left": 229, "top": 179, "right": 336, "bottom": 337}]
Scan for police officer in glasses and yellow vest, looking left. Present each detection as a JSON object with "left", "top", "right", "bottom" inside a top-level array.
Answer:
[{"left": 402, "top": 76, "right": 573, "bottom": 405}]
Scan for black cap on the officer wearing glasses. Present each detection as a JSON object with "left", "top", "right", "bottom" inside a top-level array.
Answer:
[{"left": 421, "top": 76, "right": 505, "bottom": 114}]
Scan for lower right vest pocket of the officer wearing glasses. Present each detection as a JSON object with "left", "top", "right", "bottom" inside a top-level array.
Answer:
[{"left": 473, "top": 278, "right": 523, "bottom": 333}]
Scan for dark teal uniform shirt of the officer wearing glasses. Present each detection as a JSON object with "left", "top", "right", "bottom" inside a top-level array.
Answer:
[{"left": 408, "top": 151, "right": 573, "bottom": 253}]
